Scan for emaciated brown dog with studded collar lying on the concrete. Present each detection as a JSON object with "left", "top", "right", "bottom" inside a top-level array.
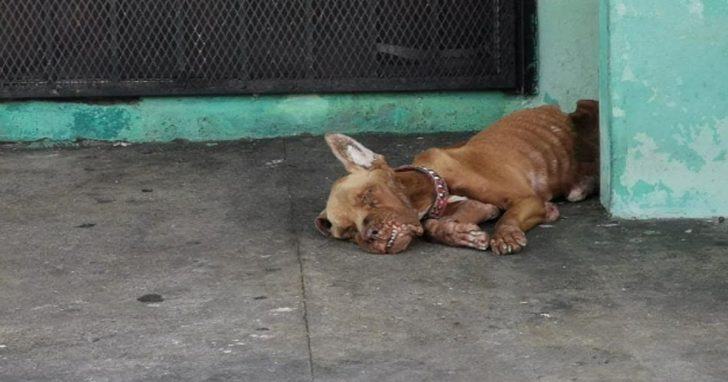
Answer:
[{"left": 316, "top": 101, "right": 599, "bottom": 255}]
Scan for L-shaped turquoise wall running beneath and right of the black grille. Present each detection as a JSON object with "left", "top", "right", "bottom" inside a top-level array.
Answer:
[{"left": 0, "top": 0, "right": 598, "bottom": 142}]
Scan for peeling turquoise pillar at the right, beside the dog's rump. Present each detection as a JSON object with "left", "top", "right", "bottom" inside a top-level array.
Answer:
[{"left": 602, "top": 0, "right": 728, "bottom": 218}]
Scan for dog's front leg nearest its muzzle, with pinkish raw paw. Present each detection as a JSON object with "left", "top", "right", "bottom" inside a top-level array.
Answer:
[{"left": 424, "top": 199, "right": 500, "bottom": 251}]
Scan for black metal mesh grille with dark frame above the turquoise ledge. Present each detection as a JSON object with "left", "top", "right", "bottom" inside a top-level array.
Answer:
[{"left": 0, "top": 0, "right": 535, "bottom": 98}]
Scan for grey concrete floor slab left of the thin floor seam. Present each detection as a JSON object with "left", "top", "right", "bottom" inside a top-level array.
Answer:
[{"left": 0, "top": 142, "right": 309, "bottom": 381}]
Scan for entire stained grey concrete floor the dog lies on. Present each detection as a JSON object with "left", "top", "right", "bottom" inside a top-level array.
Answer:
[{"left": 0, "top": 135, "right": 728, "bottom": 382}]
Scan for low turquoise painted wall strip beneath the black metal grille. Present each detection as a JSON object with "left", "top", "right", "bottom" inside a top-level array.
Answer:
[{"left": 0, "top": 93, "right": 506, "bottom": 142}]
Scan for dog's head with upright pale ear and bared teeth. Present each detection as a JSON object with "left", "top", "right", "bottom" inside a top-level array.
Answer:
[{"left": 316, "top": 134, "right": 423, "bottom": 254}]
